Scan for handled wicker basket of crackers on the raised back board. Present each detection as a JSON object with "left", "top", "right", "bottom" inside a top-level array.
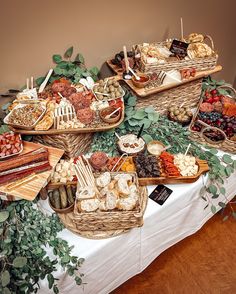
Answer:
[{"left": 138, "top": 35, "right": 218, "bottom": 73}]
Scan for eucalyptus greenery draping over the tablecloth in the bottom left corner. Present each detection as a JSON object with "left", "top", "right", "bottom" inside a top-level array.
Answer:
[{"left": 0, "top": 200, "right": 84, "bottom": 294}]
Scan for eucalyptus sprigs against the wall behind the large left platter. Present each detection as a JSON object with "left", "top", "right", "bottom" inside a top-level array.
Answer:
[{"left": 36, "top": 46, "right": 99, "bottom": 86}]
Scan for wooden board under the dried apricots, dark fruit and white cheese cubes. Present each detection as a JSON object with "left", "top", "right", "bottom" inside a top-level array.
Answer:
[{"left": 47, "top": 159, "right": 209, "bottom": 190}]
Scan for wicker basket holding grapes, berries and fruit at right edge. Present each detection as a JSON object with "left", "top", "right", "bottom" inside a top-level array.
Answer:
[{"left": 189, "top": 85, "right": 236, "bottom": 153}]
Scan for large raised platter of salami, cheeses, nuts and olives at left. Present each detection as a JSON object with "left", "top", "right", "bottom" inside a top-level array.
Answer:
[{"left": 4, "top": 78, "right": 124, "bottom": 134}]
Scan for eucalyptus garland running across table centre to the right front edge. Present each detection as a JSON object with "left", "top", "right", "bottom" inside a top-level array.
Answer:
[{"left": 91, "top": 92, "right": 236, "bottom": 220}]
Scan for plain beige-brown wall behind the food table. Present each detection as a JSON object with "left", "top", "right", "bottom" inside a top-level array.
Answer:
[{"left": 0, "top": 0, "right": 236, "bottom": 90}]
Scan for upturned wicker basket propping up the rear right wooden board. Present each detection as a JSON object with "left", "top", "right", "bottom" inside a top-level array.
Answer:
[{"left": 136, "top": 79, "right": 202, "bottom": 115}]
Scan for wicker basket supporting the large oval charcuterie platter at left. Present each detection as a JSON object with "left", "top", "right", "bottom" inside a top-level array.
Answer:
[{"left": 33, "top": 133, "right": 93, "bottom": 158}]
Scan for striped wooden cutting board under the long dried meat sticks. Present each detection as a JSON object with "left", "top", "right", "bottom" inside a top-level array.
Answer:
[{"left": 0, "top": 141, "right": 64, "bottom": 201}]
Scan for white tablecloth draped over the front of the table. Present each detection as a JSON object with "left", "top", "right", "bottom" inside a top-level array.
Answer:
[{"left": 39, "top": 173, "right": 236, "bottom": 294}]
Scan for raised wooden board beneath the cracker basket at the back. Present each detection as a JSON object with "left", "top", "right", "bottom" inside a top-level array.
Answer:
[{"left": 107, "top": 60, "right": 222, "bottom": 97}]
